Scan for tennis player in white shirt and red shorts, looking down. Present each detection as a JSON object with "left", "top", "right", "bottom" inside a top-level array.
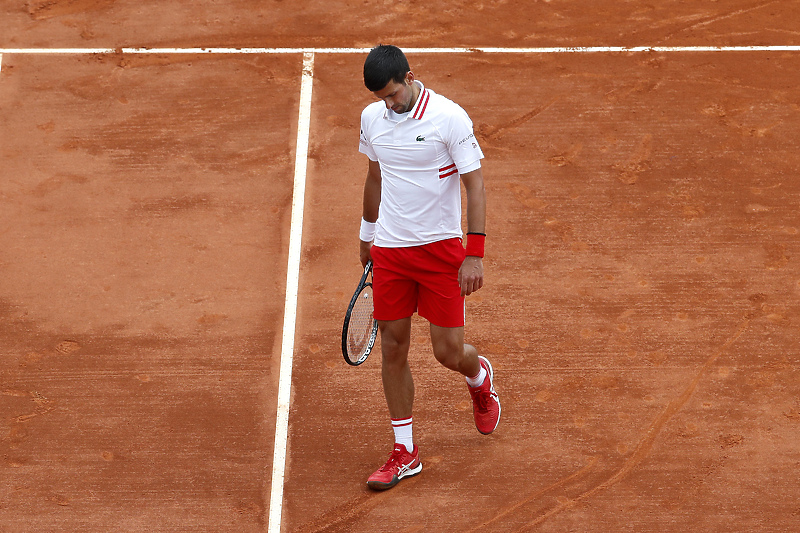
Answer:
[{"left": 359, "top": 45, "right": 500, "bottom": 490}]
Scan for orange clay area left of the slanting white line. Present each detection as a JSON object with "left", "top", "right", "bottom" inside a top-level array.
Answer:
[{"left": 0, "top": 56, "right": 299, "bottom": 531}]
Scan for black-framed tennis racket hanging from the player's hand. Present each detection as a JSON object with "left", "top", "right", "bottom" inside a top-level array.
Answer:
[{"left": 342, "top": 260, "right": 378, "bottom": 366}]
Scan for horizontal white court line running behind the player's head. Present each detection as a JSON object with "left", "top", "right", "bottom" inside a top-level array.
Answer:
[{"left": 0, "top": 46, "right": 800, "bottom": 55}]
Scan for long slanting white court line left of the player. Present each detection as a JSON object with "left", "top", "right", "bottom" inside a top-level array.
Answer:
[{"left": 267, "top": 52, "right": 314, "bottom": 533}]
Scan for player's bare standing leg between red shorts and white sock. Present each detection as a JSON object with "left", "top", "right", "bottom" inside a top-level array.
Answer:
[{"left": 378, "top": 317, "right": 414, "bottom": 418}]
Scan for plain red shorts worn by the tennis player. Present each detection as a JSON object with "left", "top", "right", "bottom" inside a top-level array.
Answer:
[{"left": 372, "top": 238, "right": 466, "bottom": 328}]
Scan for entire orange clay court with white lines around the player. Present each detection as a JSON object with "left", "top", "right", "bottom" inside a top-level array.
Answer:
[{"left": 0, "top": 0, "right": 800, "bottom": 533}]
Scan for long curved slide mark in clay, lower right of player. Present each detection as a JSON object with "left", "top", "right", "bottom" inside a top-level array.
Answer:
[{"left": 518, "top": 319, "right": 750, "bottom": 531}]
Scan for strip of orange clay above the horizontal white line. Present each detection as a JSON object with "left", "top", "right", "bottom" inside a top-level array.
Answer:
[{"left": 0, "top": 0, "right": 798, "bottom": 48}]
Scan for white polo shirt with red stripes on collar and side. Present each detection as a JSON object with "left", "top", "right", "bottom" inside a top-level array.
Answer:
[{"left": 359, "top": 81, "right": 483, "bottom": 248}]
